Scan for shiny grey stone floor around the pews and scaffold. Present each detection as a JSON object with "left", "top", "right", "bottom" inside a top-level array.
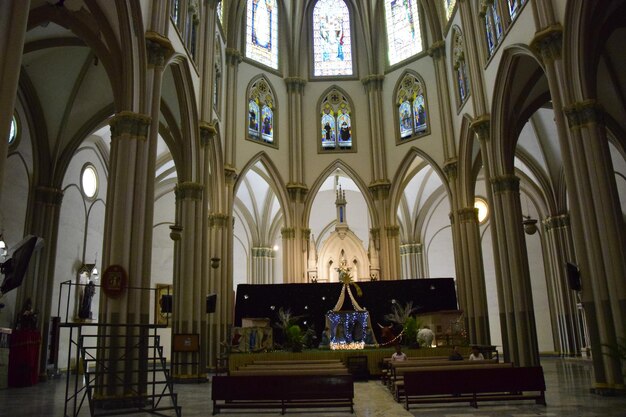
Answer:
[{"left": 0, "top": 358, "right": 626, "bottom": 417}]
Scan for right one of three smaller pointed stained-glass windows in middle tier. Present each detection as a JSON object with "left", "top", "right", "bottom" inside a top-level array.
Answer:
[{"left": 395, "top": 73, "right": 428, "bottom": 142}]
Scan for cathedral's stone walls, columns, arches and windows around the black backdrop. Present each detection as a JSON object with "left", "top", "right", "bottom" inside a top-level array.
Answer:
[{"left": 0, "top": 0, "right": 626, "bottom": 406}]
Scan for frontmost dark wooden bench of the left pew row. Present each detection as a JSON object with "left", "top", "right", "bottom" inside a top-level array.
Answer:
[{"left": 211, "top": 375, "right": 354, "bottom": 415}]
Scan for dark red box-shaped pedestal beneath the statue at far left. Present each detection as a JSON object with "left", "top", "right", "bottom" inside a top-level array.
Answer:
[{"left": 8, "top": 330, "right": 41, "bottom": 387}]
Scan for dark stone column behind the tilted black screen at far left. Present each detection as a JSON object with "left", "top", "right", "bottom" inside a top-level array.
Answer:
[{"left": 20, "top": 185, "right": 63, "bottom": 377}]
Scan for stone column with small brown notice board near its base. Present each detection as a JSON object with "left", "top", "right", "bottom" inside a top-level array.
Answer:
[{"left": 172, "top": 182, "right": 207, "bottom": 380}]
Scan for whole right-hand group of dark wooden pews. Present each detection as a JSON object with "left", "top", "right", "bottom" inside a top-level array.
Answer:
[{"left": 382, "top": 357, "right": 546, "bottom": 410}]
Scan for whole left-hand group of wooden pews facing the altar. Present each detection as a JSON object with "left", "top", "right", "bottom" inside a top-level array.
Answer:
[{"left": 211, "top": 359, "right": 354, "bottom": 415}]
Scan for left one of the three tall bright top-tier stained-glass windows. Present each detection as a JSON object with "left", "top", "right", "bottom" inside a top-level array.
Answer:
[{"left": 246, "top": 0, "right": 278, "bottom": 69}]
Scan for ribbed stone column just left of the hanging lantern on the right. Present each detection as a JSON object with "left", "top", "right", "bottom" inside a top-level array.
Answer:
[{"left": 491, "top": 175, "right": 539, "bottom": 366}]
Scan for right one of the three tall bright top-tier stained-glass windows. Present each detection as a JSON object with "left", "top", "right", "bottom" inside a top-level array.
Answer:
[{"left": 385, "top": 0, "right": 422, "bottom": 65}]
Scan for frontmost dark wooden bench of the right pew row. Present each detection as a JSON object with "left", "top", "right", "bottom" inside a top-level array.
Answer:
[{"left": 404, "top": 365, "right": 546, "bottom": 410}]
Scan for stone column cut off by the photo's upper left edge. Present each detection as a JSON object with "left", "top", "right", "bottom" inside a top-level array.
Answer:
[{"left": 0, "top": 0, "right": 30, "bottom": 206}]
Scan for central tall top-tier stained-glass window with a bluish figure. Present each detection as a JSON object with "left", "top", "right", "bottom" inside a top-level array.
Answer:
[{"left": 313, "top": 0, "right": 353, "bottom": 77}]
